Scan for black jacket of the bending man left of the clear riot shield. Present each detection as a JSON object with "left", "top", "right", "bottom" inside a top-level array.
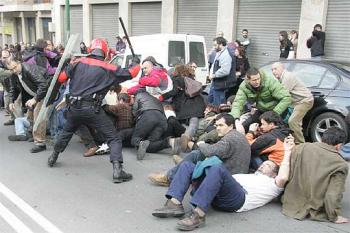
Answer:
[{"left": 9, "top": 63, "right": 48, "bottom": 102}]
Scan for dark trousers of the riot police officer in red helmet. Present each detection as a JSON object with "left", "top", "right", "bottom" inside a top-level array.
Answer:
[{"left": 54, "top": 107, "right": 123, "bottom": 162}]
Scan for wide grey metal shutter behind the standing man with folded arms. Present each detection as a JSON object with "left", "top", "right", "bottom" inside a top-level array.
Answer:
[{"left": 236, "top": 0, "right": 301, "bottom": 66}]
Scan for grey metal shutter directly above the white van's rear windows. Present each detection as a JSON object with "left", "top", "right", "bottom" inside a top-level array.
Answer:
[{"left": 176, "top": 0, "right": 218, "bottom": 49}]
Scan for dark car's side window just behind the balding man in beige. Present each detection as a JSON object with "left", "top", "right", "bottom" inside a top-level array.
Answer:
[{"left": 293, "top": 63, "right": 327, "bottom": 87}]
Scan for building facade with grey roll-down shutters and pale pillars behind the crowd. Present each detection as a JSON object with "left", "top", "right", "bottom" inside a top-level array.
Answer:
[{"left": 0, "top": 0, "right": 350, "bottom": 66}]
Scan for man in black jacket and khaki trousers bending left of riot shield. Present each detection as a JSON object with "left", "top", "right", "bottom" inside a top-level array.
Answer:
[{"left": 6, "top": 59, "right": 48, "bottom": 153}]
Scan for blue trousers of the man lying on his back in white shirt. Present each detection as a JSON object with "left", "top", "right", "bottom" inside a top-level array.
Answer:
[{"left": 165, "top": 161, "right": 245, "bottom": 213}]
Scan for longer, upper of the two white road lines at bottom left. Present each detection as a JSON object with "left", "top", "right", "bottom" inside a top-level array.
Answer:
[{"left": 0, "top": 182, "right": 63, "bottom": 233}]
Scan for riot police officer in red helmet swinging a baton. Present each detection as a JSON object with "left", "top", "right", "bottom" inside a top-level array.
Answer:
[{"left": 48, "top": 39, "right": 140, "bottom": 183}]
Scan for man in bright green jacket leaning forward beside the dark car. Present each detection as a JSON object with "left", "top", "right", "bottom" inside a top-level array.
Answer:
[{"left": 231, "top": 68, "right": 292, "bottom": 131}]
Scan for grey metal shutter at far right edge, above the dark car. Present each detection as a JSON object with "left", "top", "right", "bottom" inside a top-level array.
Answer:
[{"left": 325, "top": 0, "right": 350, "bottom": 61}]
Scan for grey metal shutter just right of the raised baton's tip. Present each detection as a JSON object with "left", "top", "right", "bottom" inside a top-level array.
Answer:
[{"left": 131, "top": 2, "right": 162, "bottom": 36}]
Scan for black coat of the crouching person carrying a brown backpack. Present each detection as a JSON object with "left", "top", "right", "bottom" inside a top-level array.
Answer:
[{"left": 163, "top": 76, "right": 205, "bottom": 120}]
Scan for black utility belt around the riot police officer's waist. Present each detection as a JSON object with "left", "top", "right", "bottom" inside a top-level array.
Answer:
[{"left": 66, "top": 93, "right": 104, "bottom": 113}]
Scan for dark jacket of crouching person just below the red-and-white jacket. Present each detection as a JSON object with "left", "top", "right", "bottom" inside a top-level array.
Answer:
[{"left": 132, "top": 88, "right": 164, "bottom": 119}]
